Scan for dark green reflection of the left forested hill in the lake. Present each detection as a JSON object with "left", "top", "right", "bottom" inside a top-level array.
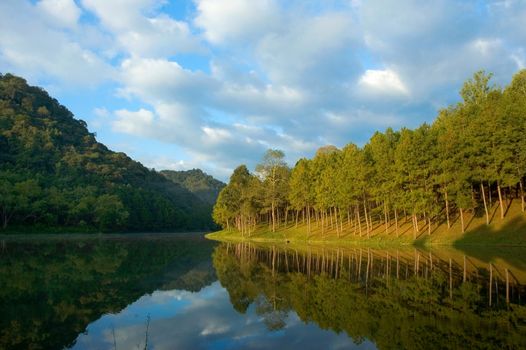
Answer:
[{"left": 0, "top": 237, "right": 214, "bottom": 349}]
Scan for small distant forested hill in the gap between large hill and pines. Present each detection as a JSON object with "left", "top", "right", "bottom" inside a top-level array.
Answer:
[{"left": 161, "top": 169, "right": 226, "bottom": 205}]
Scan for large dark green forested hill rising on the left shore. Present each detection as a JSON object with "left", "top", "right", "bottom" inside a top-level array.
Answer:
[{"left": 0, "top": 74, "right": 213, "bottom": 232}]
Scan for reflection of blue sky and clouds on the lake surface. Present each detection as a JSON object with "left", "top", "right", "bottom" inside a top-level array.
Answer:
[{"left": 73, "top": 282, "right": 374, "bottom": 349}]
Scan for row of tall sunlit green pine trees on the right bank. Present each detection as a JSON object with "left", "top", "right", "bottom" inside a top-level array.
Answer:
[{"left": 213, "top": 70, "right": 526, "bottom": 238}]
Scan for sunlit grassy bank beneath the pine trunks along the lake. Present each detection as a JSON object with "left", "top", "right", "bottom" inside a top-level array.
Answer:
[{"left": 207, "top": 201, "right": 526, "bottom": 247}]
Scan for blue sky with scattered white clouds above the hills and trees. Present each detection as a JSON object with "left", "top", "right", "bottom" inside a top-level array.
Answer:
[{"left": 0, "top": 0, "right": 526, "bottom": 180}]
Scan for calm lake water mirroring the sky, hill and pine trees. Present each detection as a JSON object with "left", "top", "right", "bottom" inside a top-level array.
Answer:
[{"left": 0, "top": 235, "right": 526, "bottom": 349}]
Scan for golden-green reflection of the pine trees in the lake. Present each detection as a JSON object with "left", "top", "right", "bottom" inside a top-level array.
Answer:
[{"left": 213, "top": 244, "right": 526, "bottom": 349}]
